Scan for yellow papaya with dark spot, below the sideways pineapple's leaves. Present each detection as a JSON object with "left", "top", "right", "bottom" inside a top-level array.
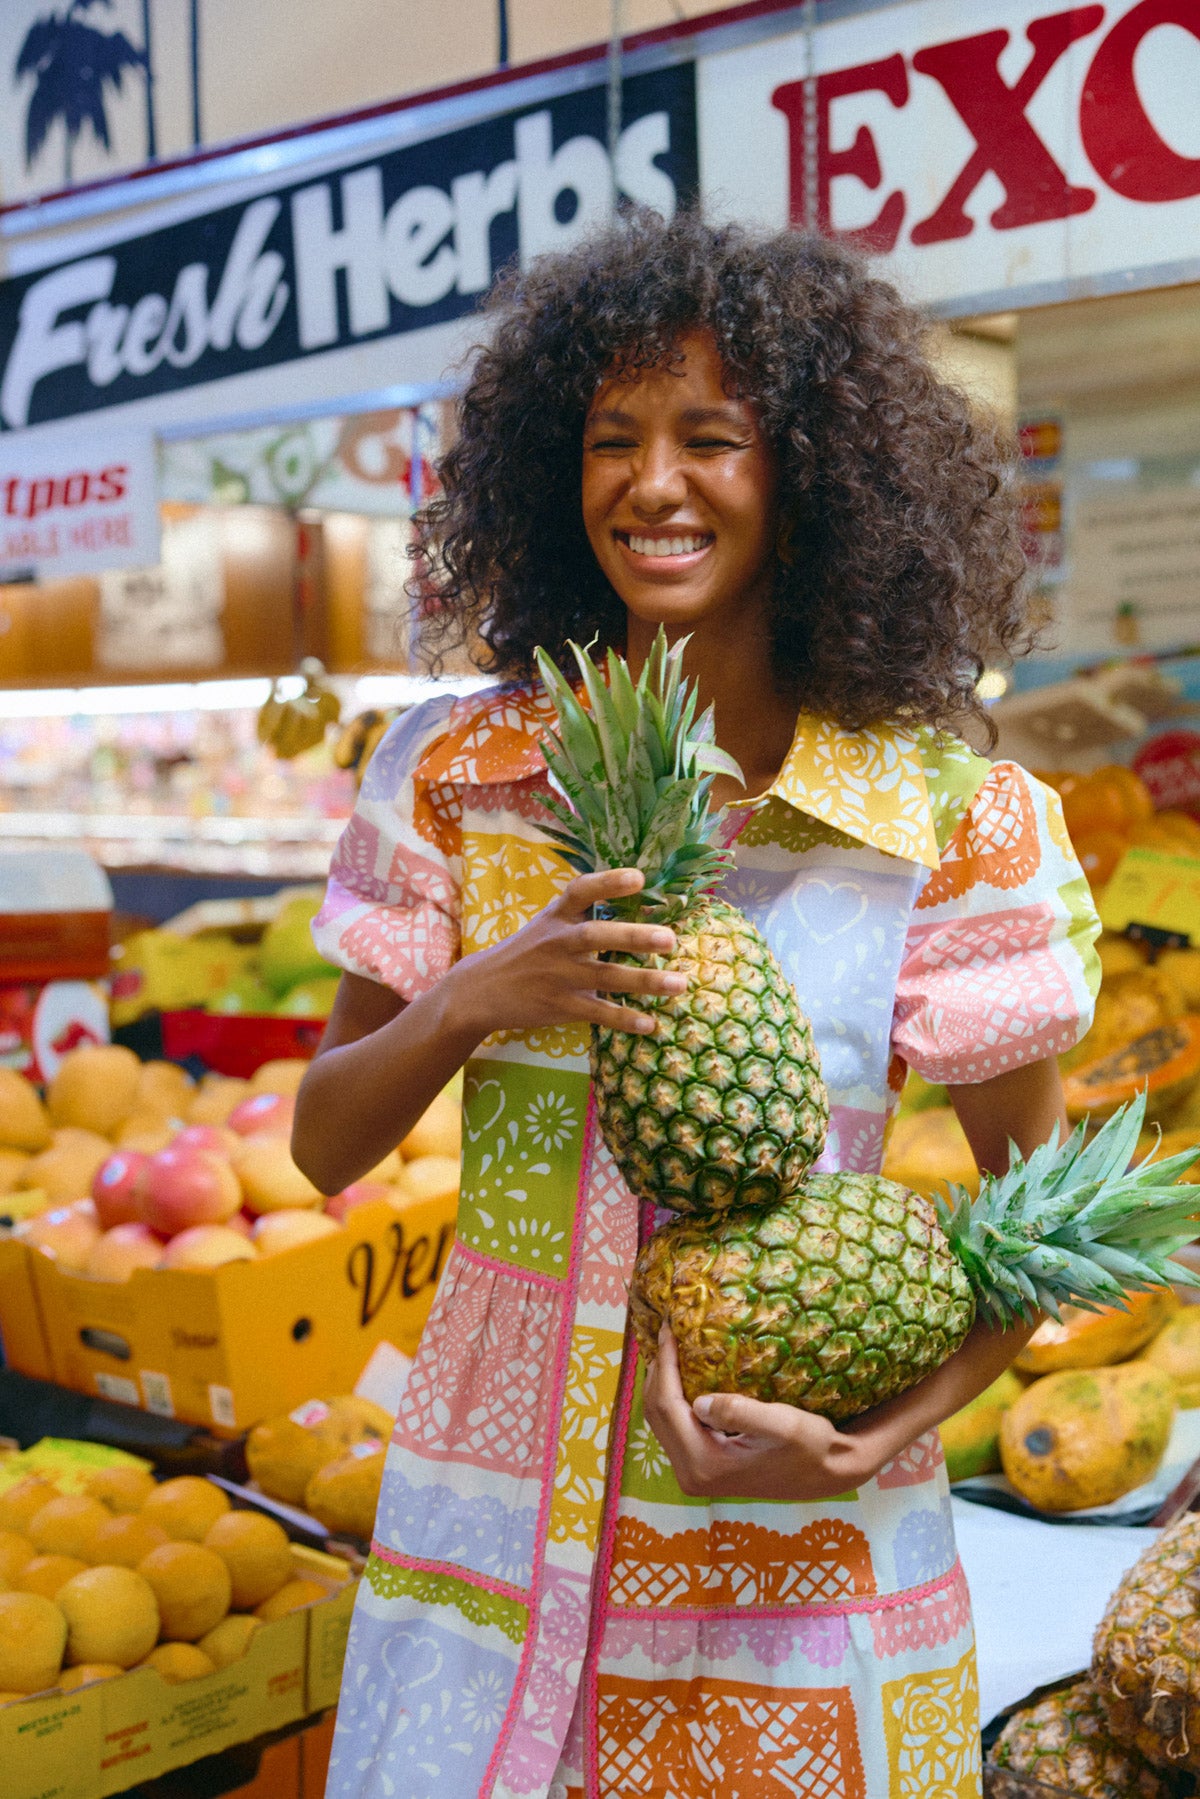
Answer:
[{"left": 1000, "top": 1362, "right": 1175, "bottom": 1511}]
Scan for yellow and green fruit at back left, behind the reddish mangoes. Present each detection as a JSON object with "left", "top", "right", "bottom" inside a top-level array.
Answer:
[{"left": 112, "top": 891, "right": 340, "bottom": 1025}]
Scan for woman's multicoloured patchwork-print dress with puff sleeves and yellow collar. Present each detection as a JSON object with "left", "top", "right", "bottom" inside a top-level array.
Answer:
[{"left": 315, "top": 684, "right": 1099, "bottom": 1799}]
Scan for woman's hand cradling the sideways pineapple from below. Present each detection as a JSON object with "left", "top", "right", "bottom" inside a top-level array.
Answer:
[{"left": 644, "top": 1324, "right": 878, "bottom": 1500}]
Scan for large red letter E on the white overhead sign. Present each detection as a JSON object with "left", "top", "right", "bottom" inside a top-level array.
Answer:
[{"left": 770, "top": 52, "right": 909, "bottom": 250}]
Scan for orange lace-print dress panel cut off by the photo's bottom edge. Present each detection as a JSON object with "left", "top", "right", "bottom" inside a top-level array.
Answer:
[{"left": 597, "top": 1675, "right": 867, "bottom": 1799}]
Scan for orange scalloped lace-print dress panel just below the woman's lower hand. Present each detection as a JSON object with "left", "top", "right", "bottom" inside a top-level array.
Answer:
[{"left": 608, "top": 1518, "right": 874, "bottom": 1608}]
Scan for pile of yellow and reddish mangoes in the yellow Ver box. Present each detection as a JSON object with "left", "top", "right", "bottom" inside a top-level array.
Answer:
[{"left": 0, "top": 1045, "right": 461, "bottom": 1281}]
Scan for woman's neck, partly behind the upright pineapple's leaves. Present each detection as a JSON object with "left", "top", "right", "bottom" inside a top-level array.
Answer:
[{"left": 626, "top": 613, "right": 797, "bottom": 806}]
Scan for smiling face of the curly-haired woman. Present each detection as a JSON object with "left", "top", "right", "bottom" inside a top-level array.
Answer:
[{"left": 583, "top": 331, "right": 779, "bottom": 630}]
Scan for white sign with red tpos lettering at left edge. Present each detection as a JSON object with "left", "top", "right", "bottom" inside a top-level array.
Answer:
[{"left": 0, "top": 426, "right": 158, "bottom": 581}]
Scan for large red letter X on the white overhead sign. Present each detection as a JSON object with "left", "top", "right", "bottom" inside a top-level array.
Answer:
[{"left": 912, "top": 5, "right": 1105, "bottom": 245}]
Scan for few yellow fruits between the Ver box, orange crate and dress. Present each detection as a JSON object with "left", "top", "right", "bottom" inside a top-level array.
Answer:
[{"left": 246, "top": 1392, "right": 392, "bottom": 1544}]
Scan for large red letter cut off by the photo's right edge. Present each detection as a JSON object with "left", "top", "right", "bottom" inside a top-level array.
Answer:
[{"left": 1079, "top": 0, "right": 1200, "bottom": 201}]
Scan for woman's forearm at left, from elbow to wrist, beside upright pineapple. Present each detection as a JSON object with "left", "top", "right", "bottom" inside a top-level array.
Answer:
[{"left": 291, "top": 970, "right": 486, "bottom": 1193}]
